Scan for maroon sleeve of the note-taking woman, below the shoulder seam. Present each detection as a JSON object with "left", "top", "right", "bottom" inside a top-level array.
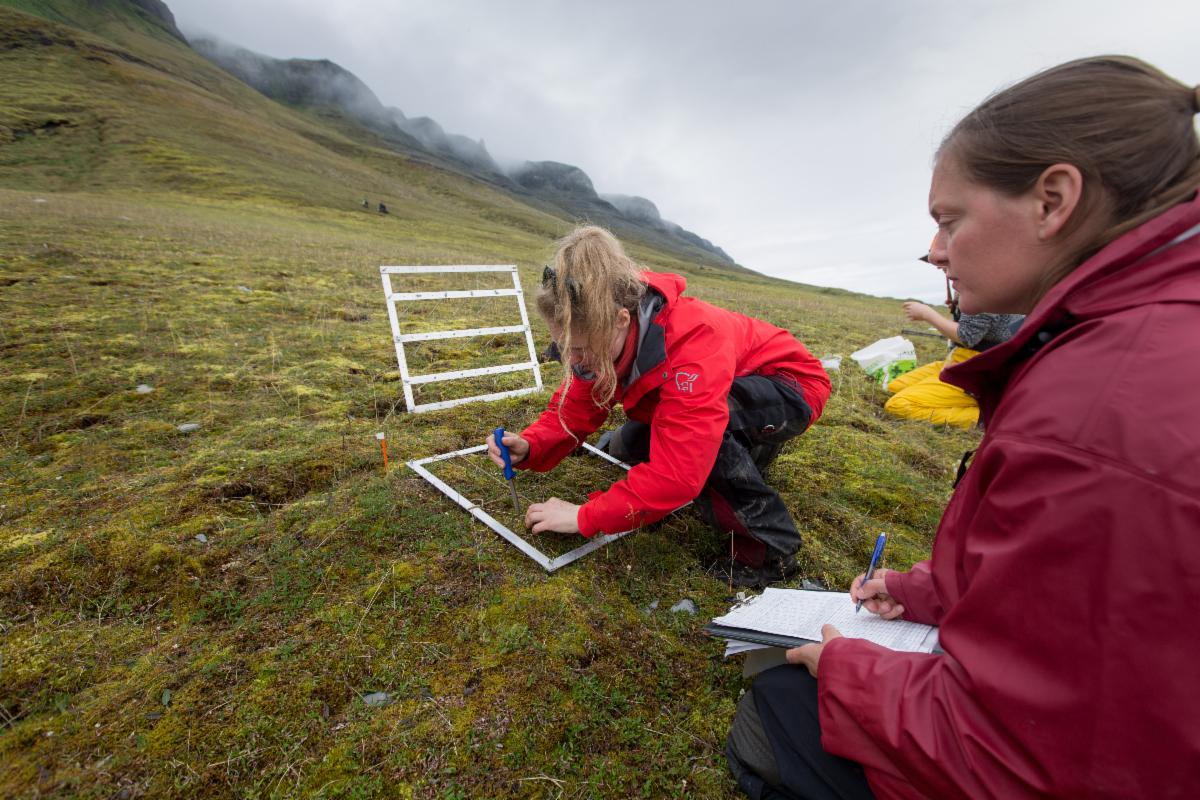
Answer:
[{"left": 817, "top": 434, "right": 1200, "bottom": 798}]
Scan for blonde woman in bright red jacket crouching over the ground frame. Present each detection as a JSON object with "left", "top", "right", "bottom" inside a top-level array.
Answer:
[{"left": 488, "top": 227, "right": 830, "bottom": 585}]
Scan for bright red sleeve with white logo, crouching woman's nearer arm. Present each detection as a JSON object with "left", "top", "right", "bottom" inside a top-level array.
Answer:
[{"left": 578, "top": 325, "right": 734, "bottom": 536}]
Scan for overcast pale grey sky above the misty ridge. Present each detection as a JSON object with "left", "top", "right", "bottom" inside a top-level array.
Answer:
[{"left": 168, "top": 0, "right": 1200, "bottom": 301}]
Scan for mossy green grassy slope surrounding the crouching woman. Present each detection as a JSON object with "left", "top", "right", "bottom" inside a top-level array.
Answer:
[{"left": 0, "top": 2, "right": 974, "bottom": 798}]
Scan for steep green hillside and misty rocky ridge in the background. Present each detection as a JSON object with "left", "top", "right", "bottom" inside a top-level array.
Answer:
[{"left": 0, "top": 0, "right": 749, "bottom": 272}]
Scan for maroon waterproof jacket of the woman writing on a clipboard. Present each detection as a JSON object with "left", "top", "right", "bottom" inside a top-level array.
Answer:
[{"left": 817, "top": 197, "right": 1200, "bottom": 800}]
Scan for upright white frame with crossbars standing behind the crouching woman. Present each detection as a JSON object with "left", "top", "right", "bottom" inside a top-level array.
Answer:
[{"left": 379, "top": 264, "right": 541, "bottom": 411}]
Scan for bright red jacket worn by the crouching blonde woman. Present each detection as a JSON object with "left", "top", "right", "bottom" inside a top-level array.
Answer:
[{"left": 520, "top": 272, "right": 830, "bottom": 536}]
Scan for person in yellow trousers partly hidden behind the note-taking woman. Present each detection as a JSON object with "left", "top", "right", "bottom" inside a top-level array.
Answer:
[{"left": 883, "top": 255, "right": 1025, "bottom": 428}]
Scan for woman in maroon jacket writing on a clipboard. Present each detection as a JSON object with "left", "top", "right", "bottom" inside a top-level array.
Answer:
[{"left": 728, "top": 56, "right": 1200, "bottom": 798}]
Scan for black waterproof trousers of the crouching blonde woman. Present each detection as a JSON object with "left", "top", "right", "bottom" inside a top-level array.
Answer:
[{"left": 601, "top": 375, "right": 812, "bottom": 566}]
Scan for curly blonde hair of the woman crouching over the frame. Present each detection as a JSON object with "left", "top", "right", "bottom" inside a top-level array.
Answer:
[{"left": 536, "top": 225, "right": 646, "bottom": 414}]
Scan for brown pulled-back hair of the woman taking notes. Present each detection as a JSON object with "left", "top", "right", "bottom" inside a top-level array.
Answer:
[{"left": 937, "top": 55, "right": 1200, "bottom": 297}]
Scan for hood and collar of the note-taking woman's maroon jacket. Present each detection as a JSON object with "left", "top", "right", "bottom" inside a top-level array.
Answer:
[{"left": 942, "top": 192, "right": 1200, "bottom": 407}]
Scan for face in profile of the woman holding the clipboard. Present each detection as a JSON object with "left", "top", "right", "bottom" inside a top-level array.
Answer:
[{"left": 929, "top": 155, "right": 1056, "bottom": 314}]
